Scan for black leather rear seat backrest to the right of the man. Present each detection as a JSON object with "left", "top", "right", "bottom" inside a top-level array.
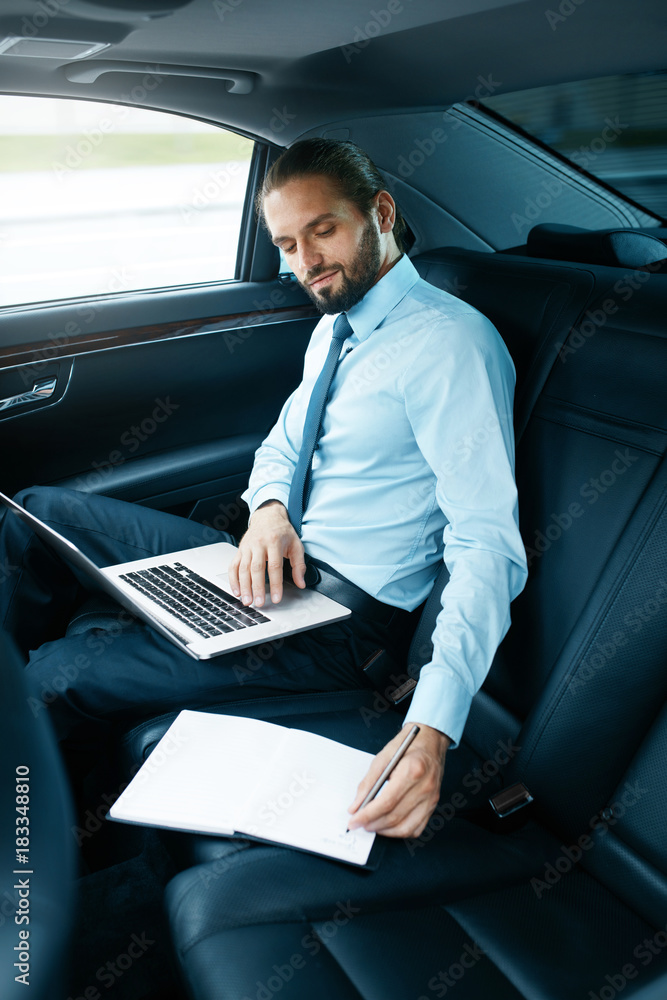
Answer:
[{"left": 418, "top": 244, "right": 667, "bottom": 927}]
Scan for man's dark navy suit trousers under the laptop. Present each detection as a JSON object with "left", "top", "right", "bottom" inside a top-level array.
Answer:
[{"left": 0, "top": 487, "right": 391, "bottom": 742}]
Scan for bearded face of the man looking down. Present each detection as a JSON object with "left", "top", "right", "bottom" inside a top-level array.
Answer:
[{"left": 264, "top": 175, "right": 383, "bottom": 313}]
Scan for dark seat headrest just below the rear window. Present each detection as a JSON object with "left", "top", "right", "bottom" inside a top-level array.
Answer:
[{"left": 527, "top": 223, "right": 667, "bottom": 269}]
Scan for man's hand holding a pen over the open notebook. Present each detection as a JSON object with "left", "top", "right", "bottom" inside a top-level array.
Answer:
[{"left": 348, "top": 724, "right": 452, "bottom": 837}]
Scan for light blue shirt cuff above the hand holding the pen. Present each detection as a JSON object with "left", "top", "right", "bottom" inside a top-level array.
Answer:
[{"left": 405, "top": 666, "right": 473, "bottom": 750}]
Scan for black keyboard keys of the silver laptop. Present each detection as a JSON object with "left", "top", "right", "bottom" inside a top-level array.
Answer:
[{"left": 120, "top": 562, "right": 270, "bottom": 638}]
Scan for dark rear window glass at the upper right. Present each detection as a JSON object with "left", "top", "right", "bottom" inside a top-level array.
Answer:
[{"left": 484, "top": 70, "right": 667, "bottom": 220}]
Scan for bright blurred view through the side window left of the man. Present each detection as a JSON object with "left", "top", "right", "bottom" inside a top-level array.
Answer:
[{"left": 0, "top": 96, "right": 253, "bottom": 305}]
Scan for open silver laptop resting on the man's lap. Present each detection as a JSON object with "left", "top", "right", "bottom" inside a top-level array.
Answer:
[{"left": 0, "top": 493, "right": 351, "bottom": 660}]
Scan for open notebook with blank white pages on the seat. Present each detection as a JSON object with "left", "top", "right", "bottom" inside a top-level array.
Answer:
[{"left": 109, "top": 709, "right": 375, "bottom": 865}]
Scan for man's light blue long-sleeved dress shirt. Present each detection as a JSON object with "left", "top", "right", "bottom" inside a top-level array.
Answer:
[{"left": 244, "top": 256, "right": 527, "bottom": 744}]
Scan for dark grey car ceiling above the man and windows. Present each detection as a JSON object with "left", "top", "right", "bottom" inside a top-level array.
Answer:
[{"left": 0, "top": 0, "right": 667, "bottom": 145}]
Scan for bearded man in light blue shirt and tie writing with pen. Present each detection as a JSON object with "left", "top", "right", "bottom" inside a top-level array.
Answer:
[{"left": 0, "top": 139, "right": 526, "bottom": 837}]
